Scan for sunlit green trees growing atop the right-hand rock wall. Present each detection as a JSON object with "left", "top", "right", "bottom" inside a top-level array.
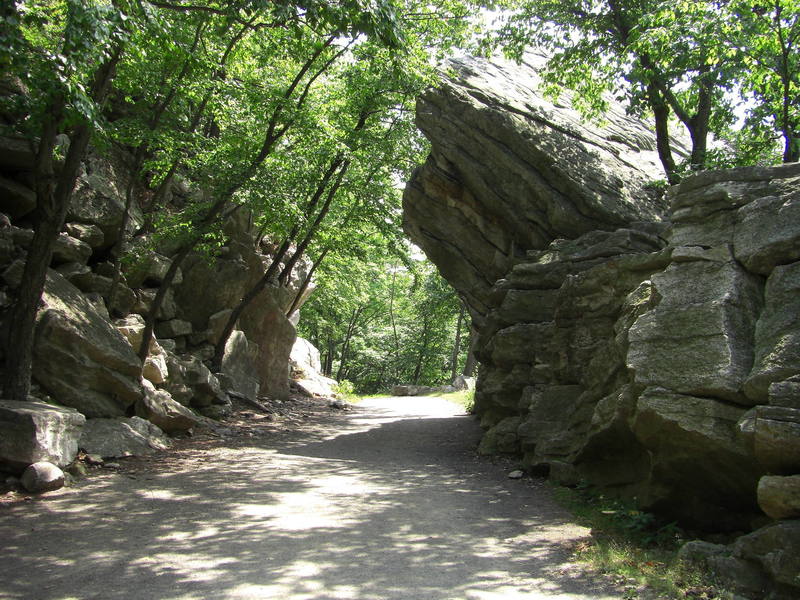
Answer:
[{"left": 486, "top": 0, "right": 800, "bottom": 182}]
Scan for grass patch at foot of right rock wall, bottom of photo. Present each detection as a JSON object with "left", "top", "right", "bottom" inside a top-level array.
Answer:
[{"left": 554, "top": 487, "right": 732, "bottom": 600}]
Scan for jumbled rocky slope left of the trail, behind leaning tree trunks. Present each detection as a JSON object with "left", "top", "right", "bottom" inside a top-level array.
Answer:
[{"left": 0, "top": 127, "right": 306, "bottom": 478}]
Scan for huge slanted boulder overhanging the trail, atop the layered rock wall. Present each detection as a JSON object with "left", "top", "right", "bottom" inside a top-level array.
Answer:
[{"left": 403, "top": 55, "right": 680, "bottom": 324}]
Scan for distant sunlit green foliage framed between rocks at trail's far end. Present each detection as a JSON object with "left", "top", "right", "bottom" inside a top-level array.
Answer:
[{"left": 299, "top": 253, "right": 468, "bottom": 394}]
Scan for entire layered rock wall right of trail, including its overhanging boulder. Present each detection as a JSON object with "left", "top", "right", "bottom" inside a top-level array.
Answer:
[{"left": 404, "top": 59, "right": 800, "bottom": 587}]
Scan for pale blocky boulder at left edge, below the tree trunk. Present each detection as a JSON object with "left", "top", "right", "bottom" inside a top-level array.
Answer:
[{"left": 0, "top": 400, "right": 86, "bottom": 472}]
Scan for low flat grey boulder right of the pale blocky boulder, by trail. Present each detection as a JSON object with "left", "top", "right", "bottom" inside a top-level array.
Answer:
[{"left": 78, "top": 417, "right": 172, "bottom": 458}]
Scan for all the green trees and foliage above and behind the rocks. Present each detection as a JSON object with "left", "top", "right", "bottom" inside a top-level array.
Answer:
[{"left": 0, "top": 0, "right": 800, "bottom": 399}]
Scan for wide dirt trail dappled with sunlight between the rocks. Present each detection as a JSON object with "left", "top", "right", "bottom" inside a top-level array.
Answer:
[{"left": 0, "top": 398, "right": 622, "bottom": 600}]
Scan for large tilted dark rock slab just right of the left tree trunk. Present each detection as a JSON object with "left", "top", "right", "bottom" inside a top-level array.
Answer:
[{"left": 33, "top": 271, "right": 143, "bottom": 417}]
